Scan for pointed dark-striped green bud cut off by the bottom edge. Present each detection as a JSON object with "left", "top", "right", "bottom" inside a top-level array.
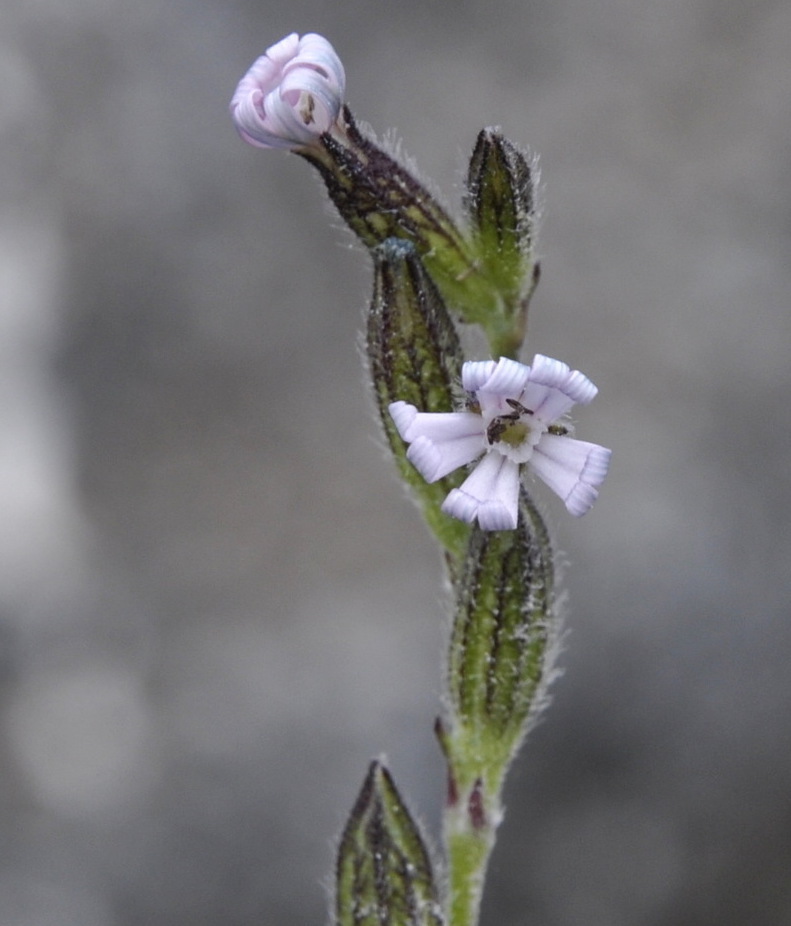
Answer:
[{"left": 335, "top": 761, "right": 443, "bottom": 926}]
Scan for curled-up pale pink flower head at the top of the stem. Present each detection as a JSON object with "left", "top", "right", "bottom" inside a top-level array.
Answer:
[{"left": 231, "top": 32, "right": 346, "bottom": 148}]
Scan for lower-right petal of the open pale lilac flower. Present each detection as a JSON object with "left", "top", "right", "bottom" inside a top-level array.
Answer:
[{"left": 530, "top": 434, "right": 612, "bottom": 517}]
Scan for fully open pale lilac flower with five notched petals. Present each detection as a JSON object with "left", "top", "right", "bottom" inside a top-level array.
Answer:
[{"left": 389, "top": 354, "right": 611, "bottom": 530}]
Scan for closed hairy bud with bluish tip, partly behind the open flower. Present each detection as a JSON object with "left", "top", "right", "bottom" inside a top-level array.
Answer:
[{"left": 366, "top": 238, "right": 469, "bottom": 556}]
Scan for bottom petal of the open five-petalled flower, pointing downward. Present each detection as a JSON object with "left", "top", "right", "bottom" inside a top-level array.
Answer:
[{"left": 442, "top": 453, "right": 519, "bottom": 530}]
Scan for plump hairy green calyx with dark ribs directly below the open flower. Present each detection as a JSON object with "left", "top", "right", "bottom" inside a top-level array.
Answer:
[{"left": 445, "top": 491, "right": 559, "bottom": 786}]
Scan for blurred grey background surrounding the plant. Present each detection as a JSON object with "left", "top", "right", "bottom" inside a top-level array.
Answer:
[{"left": 0, "top": 0, "right": 791, "bottom": 926}]
